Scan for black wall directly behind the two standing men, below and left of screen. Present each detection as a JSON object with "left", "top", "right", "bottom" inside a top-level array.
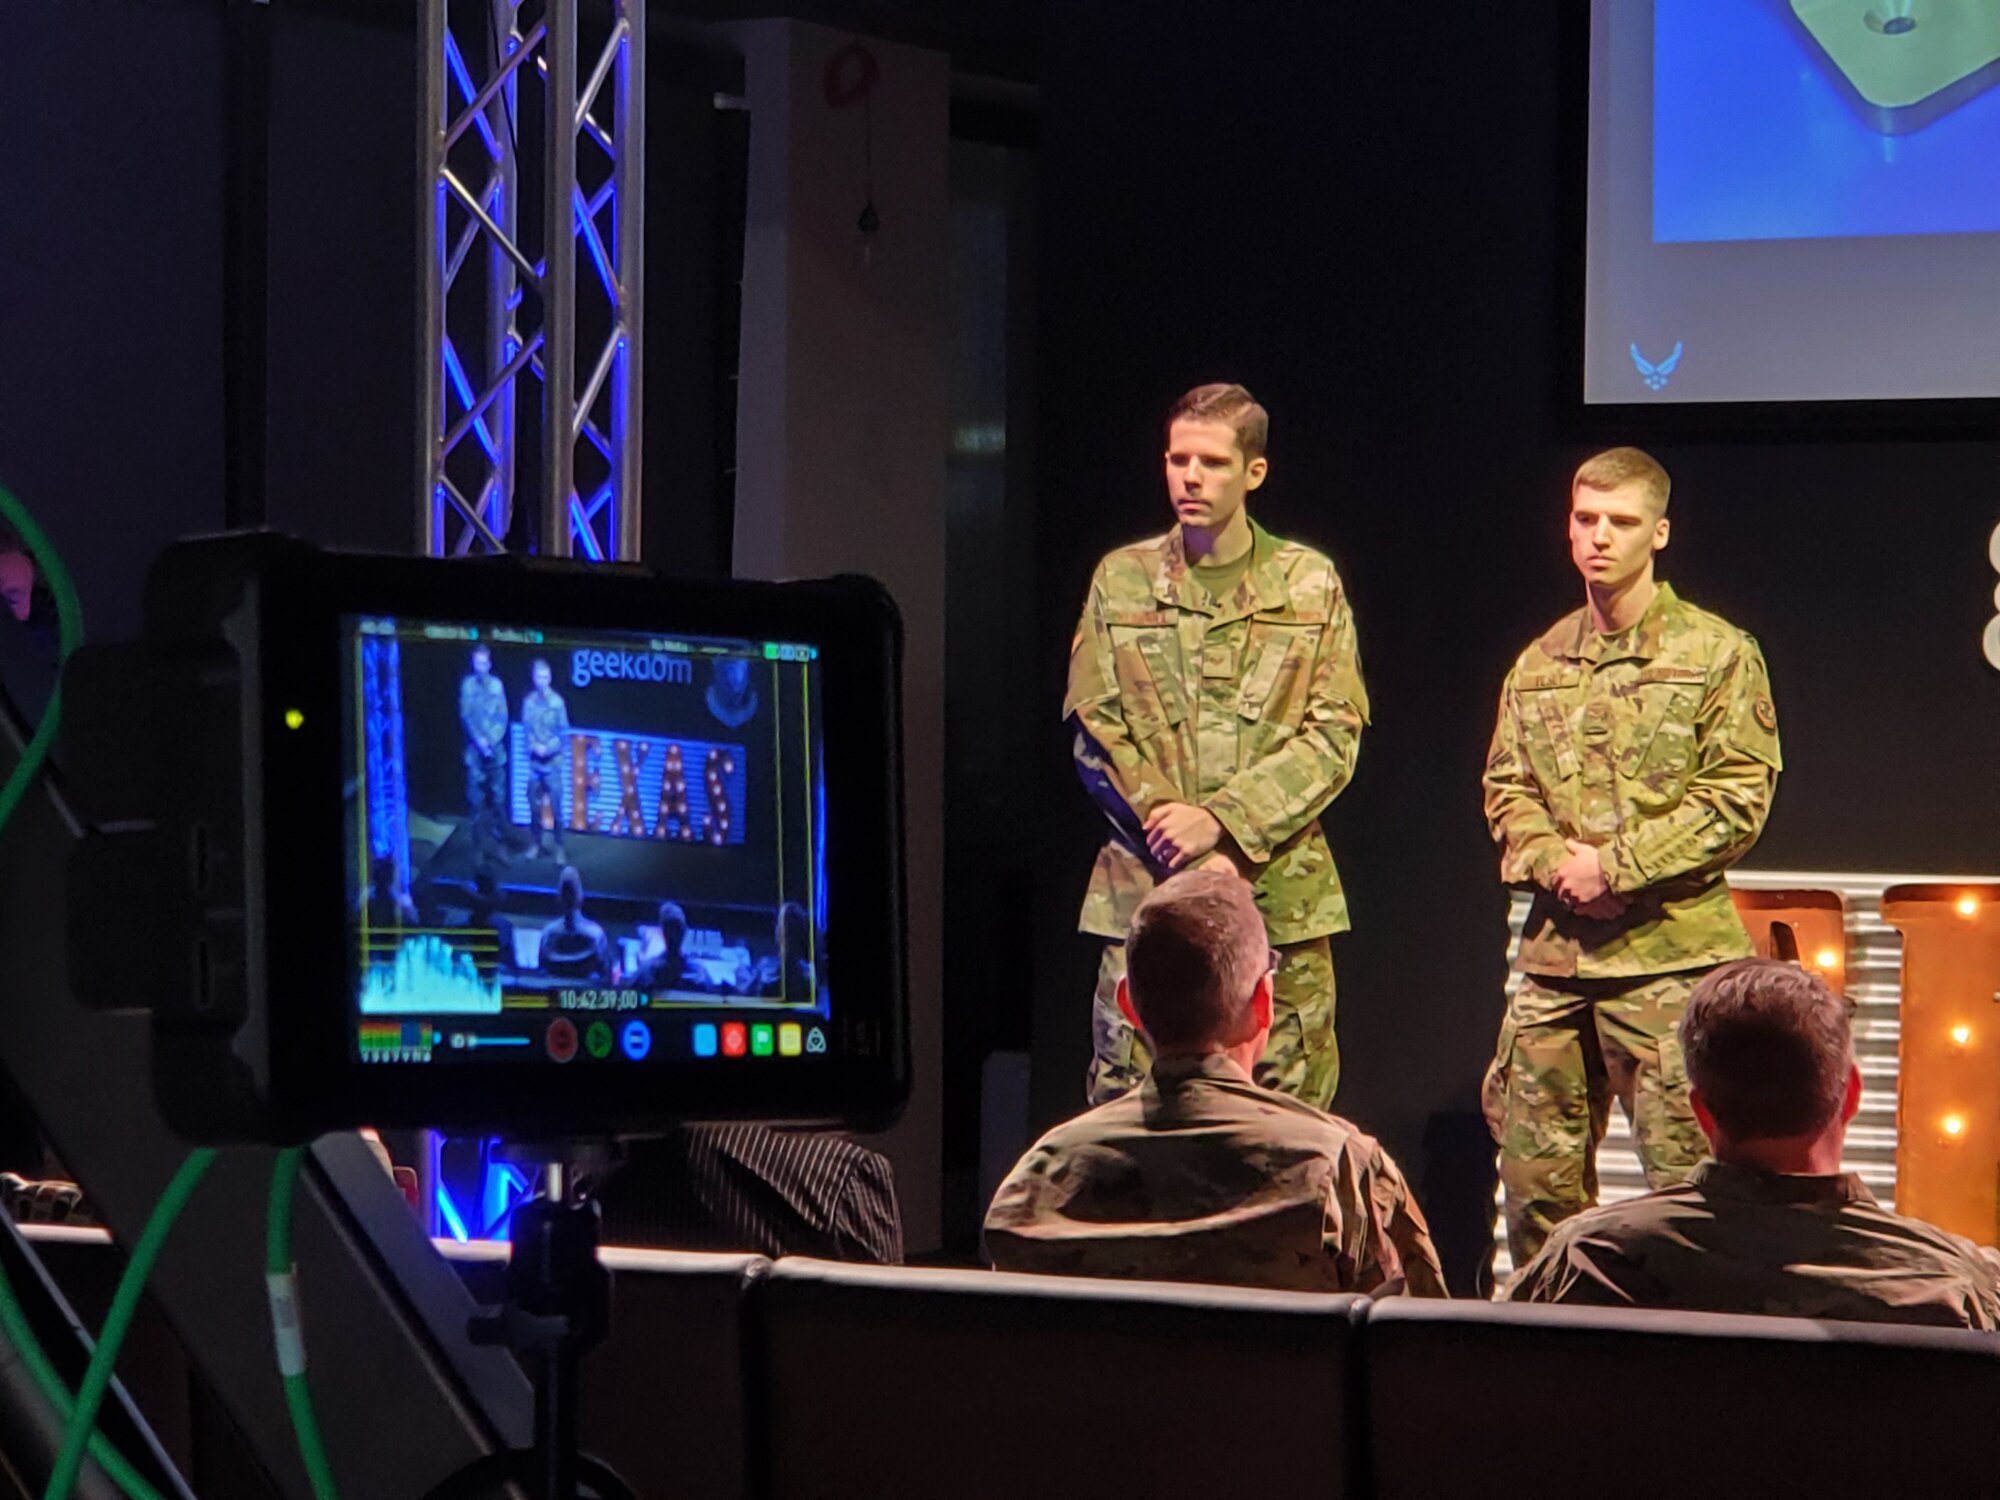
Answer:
[{"left": 1022, "top": 0, "right": 2000, "bottom": 1282}]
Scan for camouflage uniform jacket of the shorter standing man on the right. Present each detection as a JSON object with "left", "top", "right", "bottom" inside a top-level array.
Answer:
[{"left": 1486, "top": 584, "right": 1784, "bottom": 978}]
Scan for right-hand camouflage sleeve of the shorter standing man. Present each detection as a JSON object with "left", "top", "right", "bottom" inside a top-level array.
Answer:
[{"left": 1598, "top": 636, "right": 1784, "bottom": 892}]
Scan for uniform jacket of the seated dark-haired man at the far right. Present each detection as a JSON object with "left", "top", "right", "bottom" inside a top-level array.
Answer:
[{"left": 1504, "top": 1162, "right": 2000, "bottom": 1328}]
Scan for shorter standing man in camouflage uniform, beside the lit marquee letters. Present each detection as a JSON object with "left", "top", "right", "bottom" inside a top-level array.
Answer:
[{"left": 1482, "top": 448, "right": 1782, "bottom": 1264}]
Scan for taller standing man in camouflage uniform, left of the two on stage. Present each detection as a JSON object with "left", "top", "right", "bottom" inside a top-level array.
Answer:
[{"left": 1064, "top": 386, "right": 1368, "bottom": 1108}]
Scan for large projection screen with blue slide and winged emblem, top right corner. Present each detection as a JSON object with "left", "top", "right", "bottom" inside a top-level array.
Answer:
[{"left": 1582, "top": 0, "right": 2000, "bottom": 406}]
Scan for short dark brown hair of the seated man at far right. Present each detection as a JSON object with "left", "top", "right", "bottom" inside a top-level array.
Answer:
[{"left": 1680, "top": 958, "right": 1854, "bottom": 1140}]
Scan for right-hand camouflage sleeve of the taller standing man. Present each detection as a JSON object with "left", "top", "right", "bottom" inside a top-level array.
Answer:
[{"left": 1206, "top": 580, "right": 1368, "bottom": 864}]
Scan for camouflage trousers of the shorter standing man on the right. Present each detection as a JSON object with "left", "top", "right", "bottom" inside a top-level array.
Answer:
[{"left": 1480, "top": 970, "right": 1708, "bottom": 1266}]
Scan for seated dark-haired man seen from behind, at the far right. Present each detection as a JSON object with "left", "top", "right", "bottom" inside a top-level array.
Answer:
[{"left": 1504, "top": 958, "right": 2000, "bottom": 1328}]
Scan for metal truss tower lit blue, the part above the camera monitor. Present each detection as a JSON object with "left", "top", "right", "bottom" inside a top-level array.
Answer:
[{"left": 418, "top": 0, "right": 646, "bottom": 562}]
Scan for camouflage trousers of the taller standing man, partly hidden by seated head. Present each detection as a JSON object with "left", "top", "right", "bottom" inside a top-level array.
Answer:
[{"left": 1088, "top": 938, "right": 1340, "bottom": 1110}]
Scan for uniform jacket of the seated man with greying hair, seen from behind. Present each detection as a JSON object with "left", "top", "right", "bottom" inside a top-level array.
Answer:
[{"left": 986, "top": 1054, "right": 1444, "bottom": 1296}]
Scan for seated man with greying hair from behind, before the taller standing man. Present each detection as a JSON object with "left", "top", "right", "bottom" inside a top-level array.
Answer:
[{"left": 986, "top": 870, "right": 1444, "bottom": 1296}]
